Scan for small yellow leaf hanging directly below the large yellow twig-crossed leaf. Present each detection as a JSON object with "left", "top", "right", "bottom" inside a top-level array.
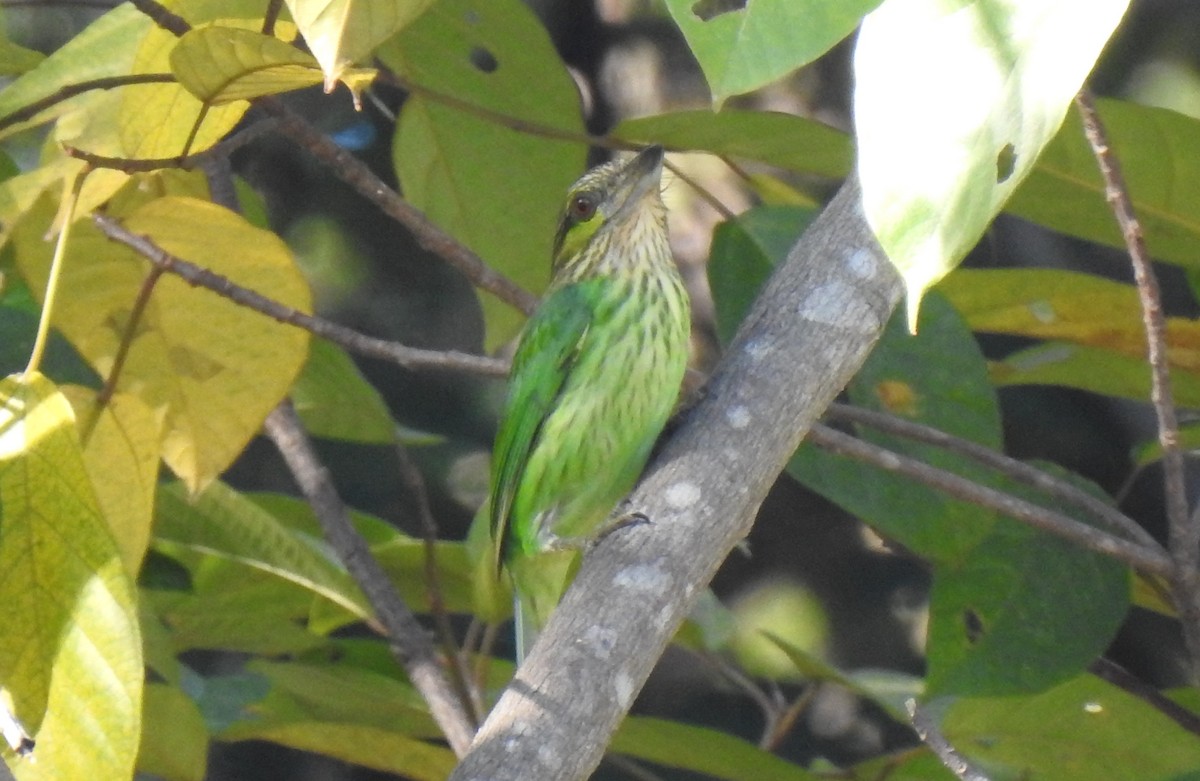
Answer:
[{"left": 64, "top": 386, "right": 166, "bottom": 578}]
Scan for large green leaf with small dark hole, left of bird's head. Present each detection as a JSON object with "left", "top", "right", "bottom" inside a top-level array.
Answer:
[{"left": 378, "top": 0, "right": 587, "bottom": 349}]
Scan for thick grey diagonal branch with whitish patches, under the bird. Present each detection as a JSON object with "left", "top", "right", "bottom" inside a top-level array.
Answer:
[{"left": 451, "top": 181, "right": 901, "bottom": 781}]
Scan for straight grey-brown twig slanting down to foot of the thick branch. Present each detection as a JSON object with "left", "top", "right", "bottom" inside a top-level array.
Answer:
[{"left": 264, "top": 402, "right": 474, "bottom": 757}]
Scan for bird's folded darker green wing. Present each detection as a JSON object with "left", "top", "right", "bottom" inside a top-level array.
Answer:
[{"left": 492, "top": 283, "right": 594, "bottom": 572}]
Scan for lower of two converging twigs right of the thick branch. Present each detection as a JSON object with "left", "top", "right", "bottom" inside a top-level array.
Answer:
[{"left": 809, "top": 423, "right": 1174, "bottom": 577}]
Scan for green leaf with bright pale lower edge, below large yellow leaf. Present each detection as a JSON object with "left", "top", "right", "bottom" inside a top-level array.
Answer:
[{"left": 155, "top": 482, "right": 372, "bottom": 619}]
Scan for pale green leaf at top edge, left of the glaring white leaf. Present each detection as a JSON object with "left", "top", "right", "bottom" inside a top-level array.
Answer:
[{"left": 667, "top": 0, "right": 881, "bottom": 106}]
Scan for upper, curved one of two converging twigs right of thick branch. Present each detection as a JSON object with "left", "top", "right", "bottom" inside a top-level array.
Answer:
[{"left": 826, "top": 403, "right": 1165, "bottom": 553}]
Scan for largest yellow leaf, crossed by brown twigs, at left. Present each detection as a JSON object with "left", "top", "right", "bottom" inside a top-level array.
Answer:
[{"left": 17, "top": 197, "right": 310, "bottom": 491}]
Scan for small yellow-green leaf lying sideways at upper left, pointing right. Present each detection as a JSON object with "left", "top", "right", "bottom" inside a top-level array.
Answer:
[{"left": 170, "top": 25, "right": 322, "bottom": 106}]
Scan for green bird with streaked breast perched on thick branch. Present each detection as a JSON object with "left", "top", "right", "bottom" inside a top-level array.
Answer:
[{"left": 491, "top": 146, "right": 691, "bottom": 660}]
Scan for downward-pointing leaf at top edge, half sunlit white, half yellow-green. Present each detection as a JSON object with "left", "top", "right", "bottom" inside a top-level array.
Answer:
[{"left": 287, "top": 0, "right": 433, "bottom": 86}]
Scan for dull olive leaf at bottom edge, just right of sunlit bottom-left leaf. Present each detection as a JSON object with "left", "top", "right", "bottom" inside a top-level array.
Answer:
[{"left": 138, "top": 684, "right": 209, "bottom": 781}]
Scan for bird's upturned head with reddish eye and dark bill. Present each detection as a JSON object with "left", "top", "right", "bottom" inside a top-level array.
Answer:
[{"left": 553, "top": 146, "right": 665, "bottom": 272}]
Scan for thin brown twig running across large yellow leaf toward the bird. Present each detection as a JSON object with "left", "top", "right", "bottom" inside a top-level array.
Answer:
[{"left": 92, "top": 214, "right": 508, "bottom": 377}]
